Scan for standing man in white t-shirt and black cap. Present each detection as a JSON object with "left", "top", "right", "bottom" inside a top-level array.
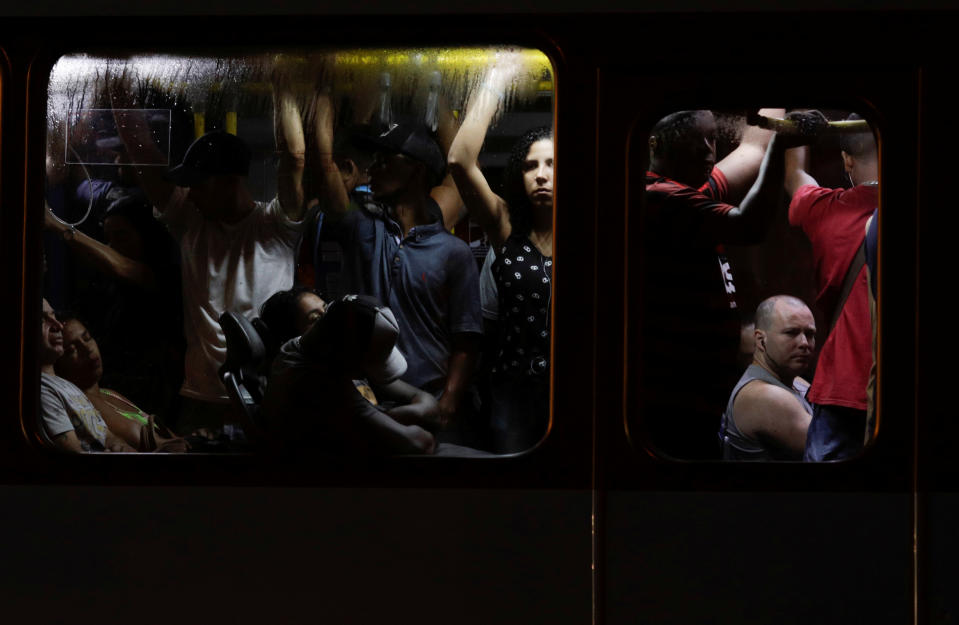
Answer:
[{"left": 118, "top": 120, "right": 302, "bottom": 434}]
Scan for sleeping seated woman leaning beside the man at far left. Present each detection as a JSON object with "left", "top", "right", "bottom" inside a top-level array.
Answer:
[{"left": 53, "top": 313, "right": 189, "bottom": 453}]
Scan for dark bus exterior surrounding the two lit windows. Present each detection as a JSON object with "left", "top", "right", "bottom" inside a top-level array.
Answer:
[{"left": 0, "top": 7, "right": 959, "bottom": 625}]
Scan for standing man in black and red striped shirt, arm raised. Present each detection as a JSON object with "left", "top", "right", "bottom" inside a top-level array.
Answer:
[{"left": 640, "top": 109, "right": 825, "bottom": 460}]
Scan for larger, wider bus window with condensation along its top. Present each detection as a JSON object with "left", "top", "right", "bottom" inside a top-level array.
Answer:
[{"left": 36, "top": 48, "right": 554, "bottom": 456}]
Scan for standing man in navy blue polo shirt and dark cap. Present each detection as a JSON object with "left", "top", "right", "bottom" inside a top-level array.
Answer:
[{"left": 326, "top": 124, "right": 483, "bottom": 434}]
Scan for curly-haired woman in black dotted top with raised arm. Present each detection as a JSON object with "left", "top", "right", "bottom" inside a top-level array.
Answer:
[{"left": 449, "top": 59, "right": 553, "bottom": 453}]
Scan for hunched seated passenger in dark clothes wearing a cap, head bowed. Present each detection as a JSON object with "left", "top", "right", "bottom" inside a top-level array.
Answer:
[{"left": 262, "top": 295, "right": 439, "bottom": 454}]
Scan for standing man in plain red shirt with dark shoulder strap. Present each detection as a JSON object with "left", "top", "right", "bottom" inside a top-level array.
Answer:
[{"left": 786, "top": 115, "right": 879, "bottom": 462}]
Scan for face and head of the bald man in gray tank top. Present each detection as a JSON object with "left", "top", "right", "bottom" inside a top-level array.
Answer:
[{"left": 756, "top": 301, "right": 816, "bottom": 379}]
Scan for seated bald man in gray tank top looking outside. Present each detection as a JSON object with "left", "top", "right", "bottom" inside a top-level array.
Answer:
[{"left": 719, "top": 295, "right": 816, "bottom": 461}]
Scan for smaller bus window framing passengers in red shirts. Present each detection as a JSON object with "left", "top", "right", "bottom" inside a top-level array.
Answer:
[{"left": 628, "top": 109, "right": 879, "bottom": 461}]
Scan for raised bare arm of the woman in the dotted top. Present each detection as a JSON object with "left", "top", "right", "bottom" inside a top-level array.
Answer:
[{"left": 448, "top": 60, "right": 518, "bottom": 247}]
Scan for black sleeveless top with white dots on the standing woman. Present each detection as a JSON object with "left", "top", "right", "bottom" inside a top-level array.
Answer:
[{"left": 492, "top": 235, "right": 553, "bottom": 377}]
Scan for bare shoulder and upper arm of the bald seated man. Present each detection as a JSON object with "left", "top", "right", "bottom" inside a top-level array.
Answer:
[{"left": 733, "top": 381, "right": 812, "bottom": 458}]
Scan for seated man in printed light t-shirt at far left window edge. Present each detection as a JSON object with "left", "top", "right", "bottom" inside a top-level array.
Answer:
[{"left": 40, "top": 300, "right": 136, "bottom": 453}]
